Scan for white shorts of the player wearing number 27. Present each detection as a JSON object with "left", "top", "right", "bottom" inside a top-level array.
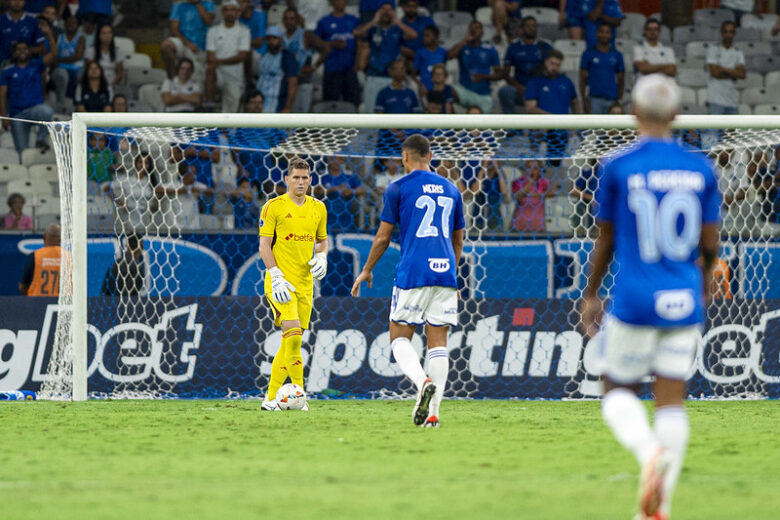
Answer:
[{"left": 390, "top": 286, "right": 458, "bottom": 327}]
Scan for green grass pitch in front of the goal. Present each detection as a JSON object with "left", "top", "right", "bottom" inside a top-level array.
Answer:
[{"left": 0, "top": 401, "right": 780, "bottom": 520}]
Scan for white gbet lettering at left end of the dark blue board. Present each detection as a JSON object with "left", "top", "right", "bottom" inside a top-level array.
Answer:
[{"left": 0, "top": 304, "right": 203, "bottom": 390}]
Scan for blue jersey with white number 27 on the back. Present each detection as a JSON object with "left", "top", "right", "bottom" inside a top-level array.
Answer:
[{"left": 380, "top": 170, "right": 466, "bottom": 289}]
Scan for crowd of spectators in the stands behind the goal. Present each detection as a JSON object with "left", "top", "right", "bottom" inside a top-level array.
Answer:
[{"left": 0, "top": 0, "right": 780, "bottom": 237}]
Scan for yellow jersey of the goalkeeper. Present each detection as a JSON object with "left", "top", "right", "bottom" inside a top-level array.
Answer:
[{"left": 260, "top": 193, "right": 328, "bottom": 292}]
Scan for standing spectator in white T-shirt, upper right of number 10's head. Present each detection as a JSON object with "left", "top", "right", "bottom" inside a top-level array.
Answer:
[{"left": 707, "top": 21, "right": 747, "bottom": 115}]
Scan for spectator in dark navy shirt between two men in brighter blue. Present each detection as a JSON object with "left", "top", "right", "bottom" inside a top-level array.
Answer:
[{"left": 498, "top": 16, "right": 552, "bottom": 114}]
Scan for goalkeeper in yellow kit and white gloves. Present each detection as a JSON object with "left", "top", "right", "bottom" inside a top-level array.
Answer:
[{"left": 260, "top": 159, "right": 328, "bottom": 411}]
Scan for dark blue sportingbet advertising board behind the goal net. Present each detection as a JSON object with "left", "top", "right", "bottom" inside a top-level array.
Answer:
[{"left": 0, "top": 296, "right": 780, "bottom": 399}]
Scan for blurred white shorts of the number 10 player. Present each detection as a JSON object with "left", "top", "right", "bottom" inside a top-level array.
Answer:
[{"left": 600, "top": 315, "right": 701, "bottom": 384}]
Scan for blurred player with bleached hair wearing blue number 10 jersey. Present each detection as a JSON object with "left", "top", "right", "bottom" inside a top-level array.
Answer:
[{"left": 581, "top": 74, "right": 720, "bottom": 520}]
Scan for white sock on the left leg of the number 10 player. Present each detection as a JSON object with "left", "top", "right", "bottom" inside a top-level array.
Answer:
[{"left": 601, "top": 388, "right": 660, "bottom": 466}]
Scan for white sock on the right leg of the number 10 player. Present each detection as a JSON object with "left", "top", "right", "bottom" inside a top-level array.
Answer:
[{"left": 655, "top": 406, "right": 690, "bottom": 516}]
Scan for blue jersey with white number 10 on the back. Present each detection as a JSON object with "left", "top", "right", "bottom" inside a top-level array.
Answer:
[{"left": 596, "top": 138, "right": 721, "bottom": 327}]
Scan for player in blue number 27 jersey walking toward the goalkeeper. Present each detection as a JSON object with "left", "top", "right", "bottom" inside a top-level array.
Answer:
[{"left": 352, "top": 134, "right": 465, "bottom": 428}]
